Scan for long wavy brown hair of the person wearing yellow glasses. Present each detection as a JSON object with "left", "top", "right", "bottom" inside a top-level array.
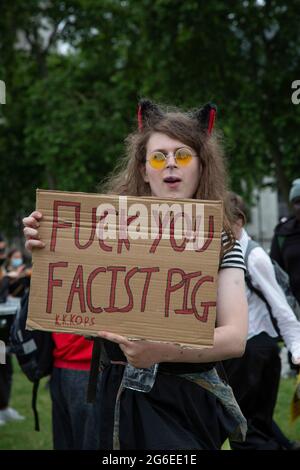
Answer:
[{"left": 101, "top": 104, "right": 235, "bottom": 251}]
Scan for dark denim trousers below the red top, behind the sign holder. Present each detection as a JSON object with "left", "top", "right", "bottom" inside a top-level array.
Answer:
[{"left": 50, "top": 368, "right": 100, "bottom": 450}]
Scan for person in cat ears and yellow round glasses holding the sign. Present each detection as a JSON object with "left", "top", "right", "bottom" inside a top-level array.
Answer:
[{"left": 24, "top": 100, "right": 248, "bottom": 449}]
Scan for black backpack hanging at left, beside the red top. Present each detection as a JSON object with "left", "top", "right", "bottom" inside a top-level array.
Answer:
[{"left": 9, "top": 292, "right": 54, "bottom": 431}]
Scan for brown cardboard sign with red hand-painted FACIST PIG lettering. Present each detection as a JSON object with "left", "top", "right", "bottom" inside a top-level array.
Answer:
[{"left": 27, "top": 190, "right": 223, "bottom": 347}]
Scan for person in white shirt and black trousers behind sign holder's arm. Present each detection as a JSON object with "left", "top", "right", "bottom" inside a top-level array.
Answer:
[{"left": 223, "top": 193, "right": 300, "bottom": 450}]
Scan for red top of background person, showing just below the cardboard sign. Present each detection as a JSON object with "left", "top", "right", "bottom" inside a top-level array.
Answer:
[{"left": 52, "top": 333, "right": 93, "bottom": 370}]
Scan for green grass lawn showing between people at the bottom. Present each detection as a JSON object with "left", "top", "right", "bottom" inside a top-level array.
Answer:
[{"left": 0, "top": 361, "right": 300, "bottom": 450}]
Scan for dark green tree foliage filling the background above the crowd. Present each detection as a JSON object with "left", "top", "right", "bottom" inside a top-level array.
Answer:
[{"left": 0, "top": 0, "right": 300, "bottom": 234}]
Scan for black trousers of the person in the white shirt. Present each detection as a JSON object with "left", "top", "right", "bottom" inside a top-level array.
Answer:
[{"left": 223, "top": 333, "right": 281, "bottom": 450}]
